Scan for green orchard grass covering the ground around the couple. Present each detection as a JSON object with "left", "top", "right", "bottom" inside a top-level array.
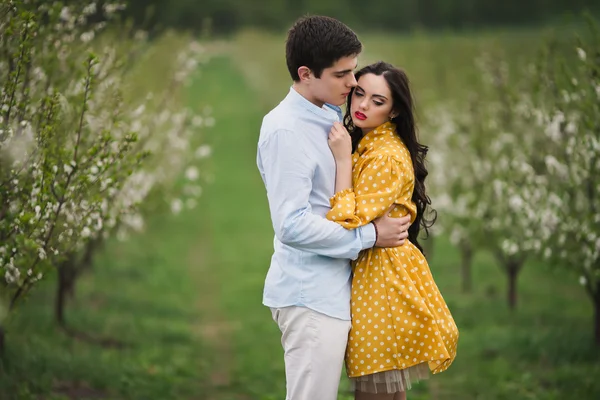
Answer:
[{"left": 0, "top": 26, "right": 600, "bottom": 400}]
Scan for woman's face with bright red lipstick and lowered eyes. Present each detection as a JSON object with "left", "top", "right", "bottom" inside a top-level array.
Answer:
[{"left": 350, "top": 74, "right": 394, "bottom": 133}]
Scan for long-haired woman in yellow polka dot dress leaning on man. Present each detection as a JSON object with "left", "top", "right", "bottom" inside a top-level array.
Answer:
[{"left": 327, "top": 62, "right": 458, "bottom": 400}]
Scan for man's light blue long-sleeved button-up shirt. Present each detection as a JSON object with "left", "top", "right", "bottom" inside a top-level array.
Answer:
[{"left": 257, "top": 88, "right": 375, "bottom": 320}]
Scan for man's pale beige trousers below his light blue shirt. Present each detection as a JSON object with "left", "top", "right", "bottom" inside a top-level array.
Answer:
[{"left": 271, "top": 306, "right": 351, "bottom": 400}]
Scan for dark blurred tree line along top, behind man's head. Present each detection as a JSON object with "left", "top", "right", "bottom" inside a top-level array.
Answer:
[{"left": 115, "top": 0, "right": 600, "bottom": 33}]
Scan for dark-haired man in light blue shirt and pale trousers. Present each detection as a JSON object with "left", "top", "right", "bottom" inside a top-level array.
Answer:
[{"left": 257, "top": 16, "right": 409, "bottom": 400}]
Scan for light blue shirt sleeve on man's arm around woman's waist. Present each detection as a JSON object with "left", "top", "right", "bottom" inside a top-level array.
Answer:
[{"left": 258, "top": 130, "right": 376, "bottom": 259}]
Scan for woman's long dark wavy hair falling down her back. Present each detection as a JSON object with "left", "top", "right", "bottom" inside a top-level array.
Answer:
[{"left": 344, "top": 61, "right": 437, "bottom": 252}]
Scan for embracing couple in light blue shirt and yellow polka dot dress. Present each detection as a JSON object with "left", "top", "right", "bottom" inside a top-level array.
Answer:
[{"left": 257, "top": 16, "right": 458, "bottom": 400}]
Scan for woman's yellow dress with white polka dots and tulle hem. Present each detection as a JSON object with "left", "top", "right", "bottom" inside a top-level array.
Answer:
[{"left": 327, "top": 122, "right": 458, "bottom": 393}]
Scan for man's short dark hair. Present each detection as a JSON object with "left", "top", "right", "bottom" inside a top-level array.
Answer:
[{"left": 285, "top": 15, "right": 362, "bottom": 82}]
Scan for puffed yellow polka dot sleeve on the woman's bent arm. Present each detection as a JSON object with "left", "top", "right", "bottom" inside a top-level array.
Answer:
[{"left": 327, "top": 156, "right": 409, "bottom": 229}]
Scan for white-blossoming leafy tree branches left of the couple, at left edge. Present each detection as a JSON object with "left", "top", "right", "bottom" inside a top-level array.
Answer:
[{"left": 0, "top": 0, "right": 213, "bottom": 346}]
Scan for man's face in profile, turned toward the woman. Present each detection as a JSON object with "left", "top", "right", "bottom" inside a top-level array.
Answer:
[{"left": 308, "top": 55, "right": 358, "bottom": 107}]
